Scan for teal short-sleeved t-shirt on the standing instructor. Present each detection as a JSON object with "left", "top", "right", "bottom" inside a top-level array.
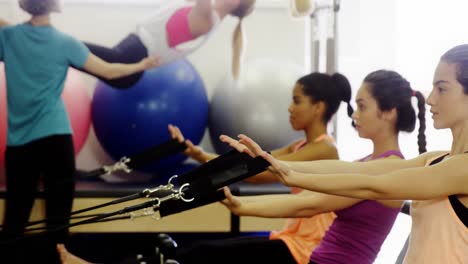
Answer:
[{"left": 0, "top": 23, "right": 89, "bottom": 146}]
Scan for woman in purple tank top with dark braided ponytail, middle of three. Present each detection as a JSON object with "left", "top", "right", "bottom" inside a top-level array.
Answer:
[{"left": 223, "top": 70, "right": 425, "bottom": 264}]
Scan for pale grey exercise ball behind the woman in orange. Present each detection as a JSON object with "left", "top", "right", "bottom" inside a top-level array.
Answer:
[{"left": 209, "top": 58, "right": 304, "bottom": 153}]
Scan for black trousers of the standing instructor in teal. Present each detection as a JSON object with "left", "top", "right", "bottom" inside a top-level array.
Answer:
[{"left": 3, "top": 135, "right": 75, "bottom": 263}]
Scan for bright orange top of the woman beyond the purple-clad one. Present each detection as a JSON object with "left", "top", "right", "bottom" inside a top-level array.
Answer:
[{"left": 270, "top": 134, "right": 336, "bottom": 264}]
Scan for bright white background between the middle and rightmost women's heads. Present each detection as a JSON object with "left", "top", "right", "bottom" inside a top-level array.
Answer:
[{"left": 396, "top": 0, "right": 468, "bottom": 153}]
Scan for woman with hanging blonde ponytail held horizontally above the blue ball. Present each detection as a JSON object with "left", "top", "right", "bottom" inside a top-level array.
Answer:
[{"left": 85, "top": 0, "right": 255, "bottom": 88}]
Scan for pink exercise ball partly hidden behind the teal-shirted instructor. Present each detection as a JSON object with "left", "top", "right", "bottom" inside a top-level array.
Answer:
[{"left": 0, "top": 64, "right": 91, "bottom": 166}]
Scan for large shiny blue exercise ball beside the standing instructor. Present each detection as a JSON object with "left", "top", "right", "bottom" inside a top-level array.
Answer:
[{"left": 91, "top": 59, "right": 208, "bottom": 172}]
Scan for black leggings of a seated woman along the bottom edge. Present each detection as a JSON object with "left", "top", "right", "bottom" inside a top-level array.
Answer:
[{"left": 125, "top": 236, "right": 297, "bottom": 264}]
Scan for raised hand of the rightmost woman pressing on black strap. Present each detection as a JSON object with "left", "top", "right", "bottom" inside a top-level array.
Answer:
[{"left": 220, "top": 134, "right": 291, "bottom": 185}]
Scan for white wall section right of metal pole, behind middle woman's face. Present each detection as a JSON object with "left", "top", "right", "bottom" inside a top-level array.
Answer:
[{"left": 337, "top": 0, "right": 398, "bottom": 160}]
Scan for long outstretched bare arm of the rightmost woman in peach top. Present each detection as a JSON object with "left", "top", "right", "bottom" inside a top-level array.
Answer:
[{"left": 286, "top": 154, "right": 468, "bottom": 200}]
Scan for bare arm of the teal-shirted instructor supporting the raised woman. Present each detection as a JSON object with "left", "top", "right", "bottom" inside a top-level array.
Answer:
[{"left": 83, "top": 53, "right": 159, "bottom": 80}]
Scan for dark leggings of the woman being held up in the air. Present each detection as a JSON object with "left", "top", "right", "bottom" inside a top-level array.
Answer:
[{"left": 80, "top": 34, "right": 148, "bottom": 89}]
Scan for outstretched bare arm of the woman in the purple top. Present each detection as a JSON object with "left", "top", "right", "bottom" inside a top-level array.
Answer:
[{"left": 222, "top": 187, "right": 360, "bottom": 218}]
